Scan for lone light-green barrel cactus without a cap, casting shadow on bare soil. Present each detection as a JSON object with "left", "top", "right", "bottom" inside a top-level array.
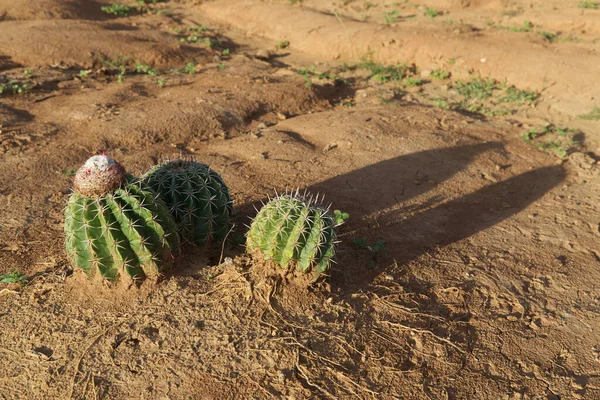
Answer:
[{"left": 246, "top": 193, "right": 348, "bottom": 279}]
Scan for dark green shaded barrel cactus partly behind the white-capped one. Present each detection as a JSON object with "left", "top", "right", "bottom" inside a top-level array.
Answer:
[{"left": 142, "top": 160, "right": 233, "bottom": 245}]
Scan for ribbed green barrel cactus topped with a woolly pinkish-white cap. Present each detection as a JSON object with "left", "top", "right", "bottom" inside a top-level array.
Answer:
[{"left": 65, "top": 154, "right": 179, "bottom": 281}]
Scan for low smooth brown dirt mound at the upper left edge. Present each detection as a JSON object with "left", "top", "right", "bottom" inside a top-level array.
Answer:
[{"left": 0, "top": 20, "right": 202, "bottom": 68}]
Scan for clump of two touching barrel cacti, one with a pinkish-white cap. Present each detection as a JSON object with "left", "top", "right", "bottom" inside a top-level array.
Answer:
[{"left": 65, "top": 154, "right": 231, "bottom": 280}]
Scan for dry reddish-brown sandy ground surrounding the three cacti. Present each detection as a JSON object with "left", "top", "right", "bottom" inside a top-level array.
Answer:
[{"left": 0, "top": 0, "right": 600, "bottom": 400}]
